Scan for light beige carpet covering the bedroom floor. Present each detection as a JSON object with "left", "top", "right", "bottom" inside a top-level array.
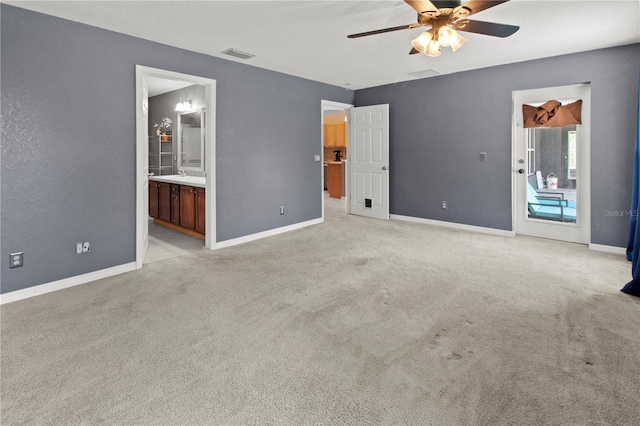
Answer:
[{"left": 1, "top": 200, "right": 640, "bottom": 425}]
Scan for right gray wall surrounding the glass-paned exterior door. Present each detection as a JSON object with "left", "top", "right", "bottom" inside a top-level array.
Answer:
[{"left": 355, "top": 44, "right": 640, "bottom": 247}]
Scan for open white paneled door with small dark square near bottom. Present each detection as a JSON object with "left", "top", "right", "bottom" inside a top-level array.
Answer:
[{"left": 348, "top": 104, "right": 389, "bottom": 219}]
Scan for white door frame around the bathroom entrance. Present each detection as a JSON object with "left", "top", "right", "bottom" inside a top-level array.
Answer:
[{"left": 136, "top": 65, "right": 216, "bottom": 269}]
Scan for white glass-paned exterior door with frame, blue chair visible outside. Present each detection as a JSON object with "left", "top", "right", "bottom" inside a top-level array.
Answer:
[{"left": 513, "top": 84, "right": 591, "bottom": 244}]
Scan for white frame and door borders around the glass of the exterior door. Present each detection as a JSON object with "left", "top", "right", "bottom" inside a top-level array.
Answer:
[{"left": 511, "top": 83, "right": 591, "bottom": 244}]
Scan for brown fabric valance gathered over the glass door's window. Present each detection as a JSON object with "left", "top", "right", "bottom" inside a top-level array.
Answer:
[{"left": 522, "top": 100, "right": 582, "bottom": 128}]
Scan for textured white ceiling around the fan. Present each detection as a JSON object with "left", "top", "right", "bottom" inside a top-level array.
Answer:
[{"left": 5, "top": 0, "right": 640, "bottom": 89}]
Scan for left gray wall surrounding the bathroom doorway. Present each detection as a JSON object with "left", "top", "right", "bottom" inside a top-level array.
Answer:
[{"left": 0, "top": 4, "right": 353, "bottom": 293}]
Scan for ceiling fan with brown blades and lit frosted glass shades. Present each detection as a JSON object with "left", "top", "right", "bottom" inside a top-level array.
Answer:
[{"left": 347, "top": 0, "right": 520, "bottom": 57}]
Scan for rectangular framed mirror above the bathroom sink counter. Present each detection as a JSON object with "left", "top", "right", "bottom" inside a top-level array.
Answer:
[{"left": 176, "top": 108, "right": 204, "bottom": 172}]
